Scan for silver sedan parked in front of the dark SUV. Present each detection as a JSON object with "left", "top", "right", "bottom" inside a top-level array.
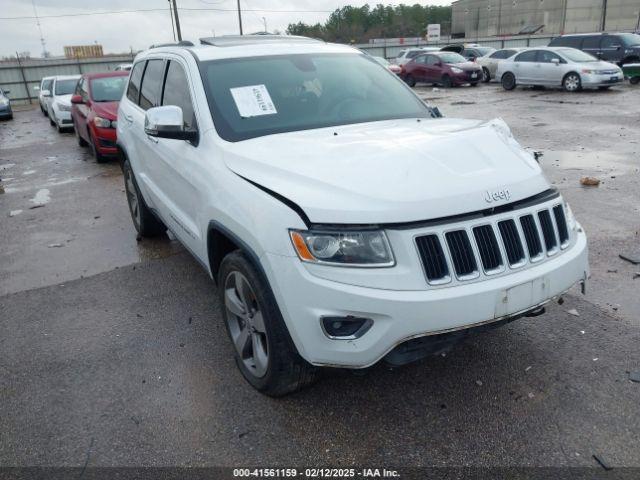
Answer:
[{"left": 497, "top": 47, "right": 624, "bottom": 92}]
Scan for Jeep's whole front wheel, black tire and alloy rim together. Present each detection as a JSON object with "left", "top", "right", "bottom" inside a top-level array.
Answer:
[{"left": 218, "top": 250, "right": 319, "bottom": 397}]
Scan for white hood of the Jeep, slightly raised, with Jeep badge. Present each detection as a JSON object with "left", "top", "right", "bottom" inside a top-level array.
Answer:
[{"left": 224, "top": 119, "right": 549, "bottom": 224}]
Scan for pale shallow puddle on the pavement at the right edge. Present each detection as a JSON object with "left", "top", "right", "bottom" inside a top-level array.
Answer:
[{"left": 542, "top": 150, "right": 639, "bottom": 175}]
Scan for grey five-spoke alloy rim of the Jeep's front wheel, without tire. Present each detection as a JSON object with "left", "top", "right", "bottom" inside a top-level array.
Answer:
[{"left": 224, "top": 270, "right": 269, "bottom": 378}]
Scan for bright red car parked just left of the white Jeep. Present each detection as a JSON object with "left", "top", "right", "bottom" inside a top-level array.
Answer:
[{"left": 71, "top": 71, "right": 129, "bottom": 163}]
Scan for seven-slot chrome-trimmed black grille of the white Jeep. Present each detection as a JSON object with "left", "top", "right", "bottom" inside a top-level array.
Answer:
[{"left": 415, "top": 204, "right": 570, "bottom": 285}]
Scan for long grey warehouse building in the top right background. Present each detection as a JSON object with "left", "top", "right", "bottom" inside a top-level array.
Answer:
[{"left": 451, "top": 0, "right": 640, "bottom": 39}]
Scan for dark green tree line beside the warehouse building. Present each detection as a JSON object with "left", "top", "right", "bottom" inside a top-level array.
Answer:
[{"left": 287, "top": 4, "right": 451, "bottom": 43}]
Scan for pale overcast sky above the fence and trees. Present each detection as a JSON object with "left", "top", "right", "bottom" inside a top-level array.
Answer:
[{"left": 0, "top": 0, "right": 451, "bottom": 57}]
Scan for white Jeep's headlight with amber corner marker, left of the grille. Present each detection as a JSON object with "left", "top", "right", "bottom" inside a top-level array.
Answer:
[{"left": 289, "top": 230, "right": 395, "bottom": 267}]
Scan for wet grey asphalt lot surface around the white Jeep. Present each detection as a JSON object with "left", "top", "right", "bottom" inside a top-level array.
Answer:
[{"left": 0, "top": 85, "right": 640, "bottom": 469}]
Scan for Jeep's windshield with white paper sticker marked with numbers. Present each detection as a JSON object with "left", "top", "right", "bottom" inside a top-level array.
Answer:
[{"left": 201, "top": 53, "right": 430, "bottom": 142}]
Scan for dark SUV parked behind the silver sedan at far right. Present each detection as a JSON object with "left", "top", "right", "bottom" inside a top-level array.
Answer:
[{"left": 549, "top": 33, "right": 640, "bottom": 65}]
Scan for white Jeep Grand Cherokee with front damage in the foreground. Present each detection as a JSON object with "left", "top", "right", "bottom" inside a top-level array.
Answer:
[{"left": 118, "top": 36, "right": 589, "bottom": 395}]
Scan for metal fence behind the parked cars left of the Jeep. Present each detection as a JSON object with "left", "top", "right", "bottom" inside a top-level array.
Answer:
[{"left": 0, "top": 55, "right": 134, "bottom": 103}]
